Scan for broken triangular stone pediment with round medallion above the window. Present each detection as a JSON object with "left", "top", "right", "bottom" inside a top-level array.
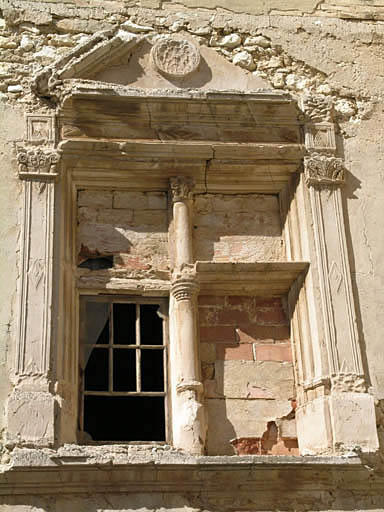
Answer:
[{"left": 34, "top": 29, "right": 271, "bottom": 97}]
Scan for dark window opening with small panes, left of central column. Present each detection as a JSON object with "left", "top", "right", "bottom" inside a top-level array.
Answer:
[{"left": 80, "top": 297, "right": 167, "bottom": 442}]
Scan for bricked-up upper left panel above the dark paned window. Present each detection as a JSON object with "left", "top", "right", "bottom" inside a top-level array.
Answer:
[{"left": 78, "top": 190, "right": 168, "bottom": 270}]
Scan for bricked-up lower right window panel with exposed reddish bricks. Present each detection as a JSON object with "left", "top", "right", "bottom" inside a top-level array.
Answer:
[{"left": 199, "top": 296, "right": 296, "bottom": 455}]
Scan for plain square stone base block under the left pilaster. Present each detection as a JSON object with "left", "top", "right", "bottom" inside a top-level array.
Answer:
[{"left": 7, "top": 390, "right": 55, "bottom": 447}]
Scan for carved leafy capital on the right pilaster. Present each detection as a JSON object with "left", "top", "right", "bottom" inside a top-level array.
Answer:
[{"left": 304, "top": 153, "right": 345, "bottom": 185}]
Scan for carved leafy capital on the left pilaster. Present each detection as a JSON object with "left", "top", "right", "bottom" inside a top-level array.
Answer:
[{"left": 17, "top": 147, "right": 60, "bottom": 181}]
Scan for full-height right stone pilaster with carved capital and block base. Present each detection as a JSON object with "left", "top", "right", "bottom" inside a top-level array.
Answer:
[{"left": 296, "top": 98, "right": 378, "bottom": 453}]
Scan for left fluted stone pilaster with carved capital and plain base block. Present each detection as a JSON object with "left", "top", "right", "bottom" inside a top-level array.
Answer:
[{"left": 7, "top": 146, "right": 60, "bottom": 446}]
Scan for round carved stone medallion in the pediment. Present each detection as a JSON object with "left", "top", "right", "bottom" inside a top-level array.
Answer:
[{"left": 151, "top": 37, "right": 200, "bottom": 78}]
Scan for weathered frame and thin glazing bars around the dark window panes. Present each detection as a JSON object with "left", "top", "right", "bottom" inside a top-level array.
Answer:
[{"left": 78, "top": 293, "right": 172, "bottom": 445}]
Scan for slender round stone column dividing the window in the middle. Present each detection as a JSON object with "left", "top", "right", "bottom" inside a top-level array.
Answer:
[{"left": 170, "top": 177, "right": 207, "bottom": 455}]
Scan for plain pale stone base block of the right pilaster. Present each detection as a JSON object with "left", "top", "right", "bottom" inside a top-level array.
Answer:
[{"left": 296, "top": 392, "right": 379, "bottom": 455}]
